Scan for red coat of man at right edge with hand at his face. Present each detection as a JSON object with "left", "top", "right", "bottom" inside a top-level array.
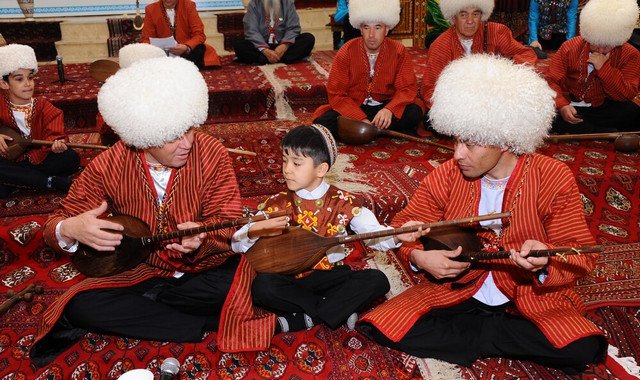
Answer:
[{"left": 546, "top": 36, "right": 640, "bottom": 109}]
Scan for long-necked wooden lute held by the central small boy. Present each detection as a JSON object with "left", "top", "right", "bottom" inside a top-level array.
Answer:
[{"left": 245, "top": 213, "right": 511, "bottom": 274}]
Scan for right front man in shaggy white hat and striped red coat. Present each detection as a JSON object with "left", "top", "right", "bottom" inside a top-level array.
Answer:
[{"left": 361, "top": 54, "right": 607, "bottom": 373}]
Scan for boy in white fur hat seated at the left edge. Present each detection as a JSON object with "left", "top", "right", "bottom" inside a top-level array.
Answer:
[{"left": 0, "top": 44, "right": 80, "bottom": 198}]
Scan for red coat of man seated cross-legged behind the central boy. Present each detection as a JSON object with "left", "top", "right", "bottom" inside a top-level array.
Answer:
[{"left": 313, "top": 37, "right": 418, "bottom": 120}]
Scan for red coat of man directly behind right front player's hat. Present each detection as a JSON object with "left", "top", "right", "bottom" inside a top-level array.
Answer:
[{"left": 420, "top": 22, "right": 537, "bottom": 109}]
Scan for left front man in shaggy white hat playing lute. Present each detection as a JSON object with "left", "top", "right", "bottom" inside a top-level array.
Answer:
[{"left": 30, "top": 57, "right": 241, "bottom": 366}]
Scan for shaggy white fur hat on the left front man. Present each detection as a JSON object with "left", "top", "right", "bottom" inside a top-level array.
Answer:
[{"left": 98, "top": 57, "right": 209, "bottom": 149}]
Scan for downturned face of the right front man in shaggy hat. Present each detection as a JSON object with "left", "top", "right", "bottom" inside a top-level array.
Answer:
[{"left": 453, "top": 140, "right": 506, "bottom": 179}]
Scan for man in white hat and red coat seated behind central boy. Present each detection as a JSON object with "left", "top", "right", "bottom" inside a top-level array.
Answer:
[{"left": 313, "top": 0, "right": 422, "bottom": 137}]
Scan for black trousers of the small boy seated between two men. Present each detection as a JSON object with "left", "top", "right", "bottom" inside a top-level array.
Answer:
[{"left": 251, "top": 265, "right": 389, "bottom": 329}]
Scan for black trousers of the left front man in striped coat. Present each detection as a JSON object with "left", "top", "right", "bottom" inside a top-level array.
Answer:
[{"left": 64, "top": 256, "right": 239, "bottom": 342}]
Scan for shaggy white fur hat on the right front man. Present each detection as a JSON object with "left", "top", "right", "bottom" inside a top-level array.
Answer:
[{"left": 429, "top": 54, "right": 556, "bottom": 154}]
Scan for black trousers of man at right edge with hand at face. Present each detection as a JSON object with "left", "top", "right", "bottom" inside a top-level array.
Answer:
[{"left": 551, "top": 100, "right": 640, "bottom": 134}]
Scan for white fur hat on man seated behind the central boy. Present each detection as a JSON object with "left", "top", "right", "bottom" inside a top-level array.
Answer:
[{"left": 349, "top": 0, "right": 400, "bottom": 29}]
